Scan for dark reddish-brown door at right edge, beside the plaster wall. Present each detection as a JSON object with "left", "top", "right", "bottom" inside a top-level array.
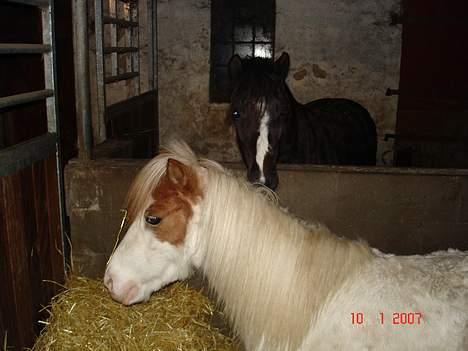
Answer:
[{"left": 395, "top": 0, "right": 468, "bottom": 168}]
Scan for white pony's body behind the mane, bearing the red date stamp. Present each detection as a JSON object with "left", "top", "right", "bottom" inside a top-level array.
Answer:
[{"left": 301, "top": 250, "right": 468, "bottom": 351}]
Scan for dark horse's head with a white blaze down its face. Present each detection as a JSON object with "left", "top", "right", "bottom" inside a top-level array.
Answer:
[{"left": 229, "top": 53, "right": 290, "bottom": 190}]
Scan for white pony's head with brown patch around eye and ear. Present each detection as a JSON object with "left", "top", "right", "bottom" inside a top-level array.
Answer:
[{"left": 104, "top": 143, "right": 208, "bottom": 305}]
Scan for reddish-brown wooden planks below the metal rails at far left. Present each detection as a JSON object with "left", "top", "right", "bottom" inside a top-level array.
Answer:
[{"left": 0, "top": 155, "right": 64, "bottom": 349}]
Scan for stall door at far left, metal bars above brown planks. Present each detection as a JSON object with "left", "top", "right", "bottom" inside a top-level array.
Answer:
[{"left": 0, "top": 1, "right": 67, "bottom": 350}]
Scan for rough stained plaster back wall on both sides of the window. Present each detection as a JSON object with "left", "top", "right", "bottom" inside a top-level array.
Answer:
[{"left": 158, "top": 0, "right": 401, "bottom": 162}]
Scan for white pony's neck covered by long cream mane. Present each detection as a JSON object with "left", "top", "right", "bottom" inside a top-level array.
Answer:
[{"left": 200, "top": 173, "right": 371, "bottom": 350}]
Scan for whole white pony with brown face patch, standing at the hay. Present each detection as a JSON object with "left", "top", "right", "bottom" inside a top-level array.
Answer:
[{"left": 104, "top": 142, "right": 468, "bottom": 351}]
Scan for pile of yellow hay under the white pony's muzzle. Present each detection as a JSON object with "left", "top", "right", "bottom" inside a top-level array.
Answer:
[{"left": 33, "top": 277, "right": 239, "bottom": 351}]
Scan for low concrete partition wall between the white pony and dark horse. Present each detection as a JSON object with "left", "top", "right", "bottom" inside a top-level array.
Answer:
[{"left": 65, "top": 159, "right": 468, "bottom": 277}]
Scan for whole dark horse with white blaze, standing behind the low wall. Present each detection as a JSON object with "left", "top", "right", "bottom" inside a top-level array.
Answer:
[{"left": 229, "top": 52, "right": 377, "bottom": 189}]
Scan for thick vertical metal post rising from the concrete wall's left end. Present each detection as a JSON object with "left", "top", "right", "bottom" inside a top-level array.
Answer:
[{"left": 73, "top": 0, "right": 93, "bottom": 160}]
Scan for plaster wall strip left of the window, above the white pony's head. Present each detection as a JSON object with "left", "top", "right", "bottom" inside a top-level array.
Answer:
[{"left": 158, "top": 0, "right": 239, "bottom": 160}]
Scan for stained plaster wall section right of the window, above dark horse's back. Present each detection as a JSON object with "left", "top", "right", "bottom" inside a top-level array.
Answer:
[{"left": 276, "top": 0, "right": 401, "bottom": 165}]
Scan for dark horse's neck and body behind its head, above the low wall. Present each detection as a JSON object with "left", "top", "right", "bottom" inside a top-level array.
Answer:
[{"left": 278, "top": 86, "right": 377, "bottom": 165}]
